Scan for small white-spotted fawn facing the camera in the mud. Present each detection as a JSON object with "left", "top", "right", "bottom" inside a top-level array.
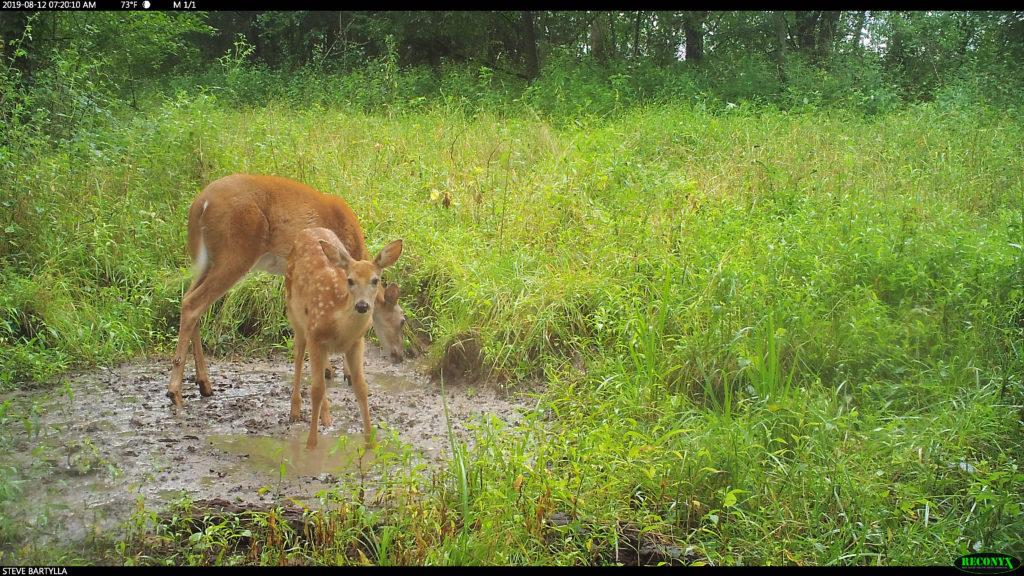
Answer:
[{"left": 285, "top": 228, "right": 401, "bottom": 448}]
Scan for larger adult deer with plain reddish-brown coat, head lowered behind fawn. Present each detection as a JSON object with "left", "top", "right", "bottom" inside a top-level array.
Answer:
[{"left": 167, "top": 174, "right": 406, "bottom": 406}]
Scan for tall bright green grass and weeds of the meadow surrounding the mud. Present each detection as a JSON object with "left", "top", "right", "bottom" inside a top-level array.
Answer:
[{"left": 0, "top": 96, "right": 1024, "bottom": 565}]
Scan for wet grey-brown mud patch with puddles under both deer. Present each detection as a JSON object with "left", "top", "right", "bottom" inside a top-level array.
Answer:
[{"left": 0, "top": 345, "right": 532, "bottom": 542}]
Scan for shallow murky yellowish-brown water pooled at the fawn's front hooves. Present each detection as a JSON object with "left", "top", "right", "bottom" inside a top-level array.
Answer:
[{"left": 209, "top": 428, "right": 377, "bottom": 478}]
